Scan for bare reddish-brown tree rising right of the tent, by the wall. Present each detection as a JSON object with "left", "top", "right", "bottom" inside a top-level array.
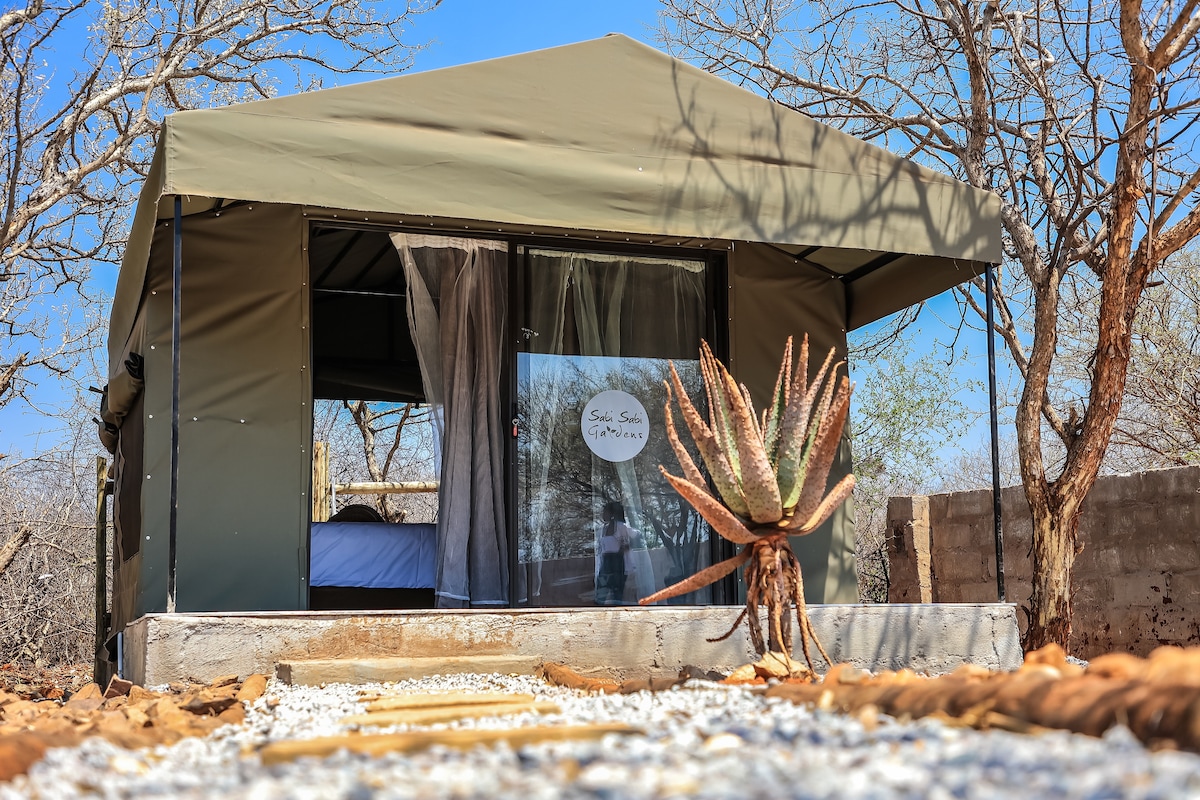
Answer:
[{"left": 662, "top": 0, "right": 1200, "bottom": 648}]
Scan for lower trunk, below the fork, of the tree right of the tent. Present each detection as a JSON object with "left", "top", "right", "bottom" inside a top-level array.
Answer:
[{"left": 1022, "top": 503, "right": 1079, "bottom": 652}]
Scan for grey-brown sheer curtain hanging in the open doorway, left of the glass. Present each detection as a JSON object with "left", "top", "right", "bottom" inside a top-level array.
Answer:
[{"left": 391, "top": 233, "right": 509, "bottom": 608}]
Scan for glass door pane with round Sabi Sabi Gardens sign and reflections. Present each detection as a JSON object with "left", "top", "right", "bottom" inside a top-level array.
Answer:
[{"left": 515, "top": 249, "right": 712, "bottom": 606}]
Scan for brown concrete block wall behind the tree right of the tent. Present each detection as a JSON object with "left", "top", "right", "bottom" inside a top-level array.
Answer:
[{"left": 888, "top": 467, "right": 1200, "bottom": 658}]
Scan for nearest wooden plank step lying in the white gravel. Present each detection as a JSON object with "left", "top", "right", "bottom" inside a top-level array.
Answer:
[{"left": 258, "top": 723, "right": 641, "bottom": 765}]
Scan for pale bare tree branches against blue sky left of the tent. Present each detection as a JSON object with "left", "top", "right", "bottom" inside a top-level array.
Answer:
[{"left": 0, "top": 0, "right": 440, "bottom": 405}]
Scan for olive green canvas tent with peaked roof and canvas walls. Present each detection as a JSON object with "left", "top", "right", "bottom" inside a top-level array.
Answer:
[{"left": 104, "top": 36, "right": 1001, "bottom": 630}]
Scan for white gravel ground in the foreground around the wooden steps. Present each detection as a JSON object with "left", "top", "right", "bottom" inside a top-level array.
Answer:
[{"left": 7, "top": 675, "right": 1200, "bottom": 800}]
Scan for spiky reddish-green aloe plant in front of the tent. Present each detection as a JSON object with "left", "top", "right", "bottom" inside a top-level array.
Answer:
[{"left": 641, "top": 336, "right": 854, "bottom": 669}]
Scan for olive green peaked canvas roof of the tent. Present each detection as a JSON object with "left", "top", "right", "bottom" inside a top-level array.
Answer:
[{"left": 109, "top": 35, "right": 1001, "bottom": 376}]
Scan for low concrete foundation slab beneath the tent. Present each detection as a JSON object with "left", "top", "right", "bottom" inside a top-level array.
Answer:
[{"left": 124, "top": 603, "right": 1021, "bottom": 686}]
